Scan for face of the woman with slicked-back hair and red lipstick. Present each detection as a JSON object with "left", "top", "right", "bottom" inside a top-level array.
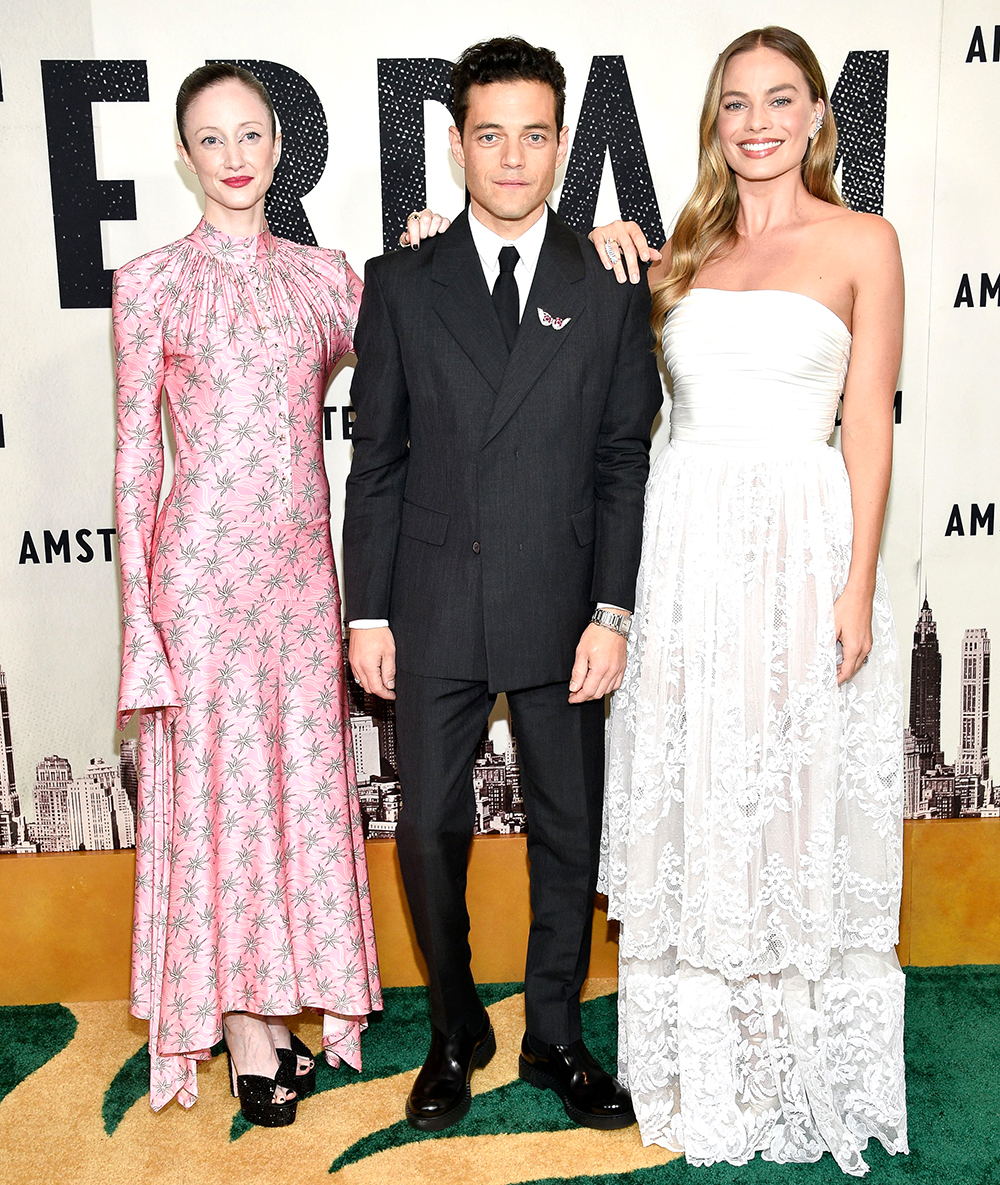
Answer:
[{"left": 177, "top": 78, "right": 281, "bottom": 220}]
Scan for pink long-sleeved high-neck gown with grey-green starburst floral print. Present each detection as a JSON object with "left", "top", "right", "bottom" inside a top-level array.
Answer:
[{"left": 113, "top": 220, "right": 382, "bottom": 1109}]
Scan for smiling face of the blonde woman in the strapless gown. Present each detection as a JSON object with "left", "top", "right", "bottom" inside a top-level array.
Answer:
[{"left": 718, "top": 49, "right": 823, "bottom": 181}]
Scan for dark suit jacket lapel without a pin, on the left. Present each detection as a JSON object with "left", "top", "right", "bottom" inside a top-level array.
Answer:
[{"left": 430, "top": 212, "right": 511, "bottom": 393}]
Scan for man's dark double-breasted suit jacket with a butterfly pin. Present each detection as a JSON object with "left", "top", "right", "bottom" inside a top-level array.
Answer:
[{"left": 345, "top": 211, "right": 661, "bottom": 691}]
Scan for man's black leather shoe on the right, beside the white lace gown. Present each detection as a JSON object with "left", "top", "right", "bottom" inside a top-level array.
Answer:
[{"left": 518, "top": 1033, "right": 635, "bottom": 1130}]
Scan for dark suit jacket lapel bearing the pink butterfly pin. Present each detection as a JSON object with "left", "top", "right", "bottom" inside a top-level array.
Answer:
[{"left": 483, "top": 210, "right": 586, "bottom": 447}]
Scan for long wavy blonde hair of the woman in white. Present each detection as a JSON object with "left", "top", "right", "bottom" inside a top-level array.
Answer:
[{"left": 650, "top": 25, "right": 844, "bottom": 347}]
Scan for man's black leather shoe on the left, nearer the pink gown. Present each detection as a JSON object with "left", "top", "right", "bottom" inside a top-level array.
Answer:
[{"left": 406, "top": 1008, "right": 496, "bottom": 1132}]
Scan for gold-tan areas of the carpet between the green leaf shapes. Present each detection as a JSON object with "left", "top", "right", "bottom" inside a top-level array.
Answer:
[{"left": 0, "top": 980, "right": 672, "bottom": 1185}]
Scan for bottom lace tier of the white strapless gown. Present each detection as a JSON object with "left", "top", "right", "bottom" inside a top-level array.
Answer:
[{"left": 618, "top": 950, "right": 908, "bottom": 1176}]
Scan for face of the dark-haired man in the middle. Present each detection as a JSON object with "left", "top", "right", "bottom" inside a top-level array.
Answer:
[{"left": 450, "top": 81, "right": 569, "bottom": 238}]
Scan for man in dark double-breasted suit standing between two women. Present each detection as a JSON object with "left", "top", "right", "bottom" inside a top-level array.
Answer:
[{"left": 344, "top": 38, "right": 661, "bottom": 1130}]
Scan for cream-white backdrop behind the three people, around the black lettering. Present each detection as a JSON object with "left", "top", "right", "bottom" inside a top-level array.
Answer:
[{"left": 0, "top": 0, "right": 1000, "bottom": 848}]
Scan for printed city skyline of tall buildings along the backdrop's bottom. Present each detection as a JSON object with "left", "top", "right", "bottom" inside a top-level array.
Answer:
[{"left": 0, "top": 596, "right": 1000, "bottom": 854}]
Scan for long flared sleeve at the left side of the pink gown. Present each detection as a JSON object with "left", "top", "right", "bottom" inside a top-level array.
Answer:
[{"left": 111, "top": 260, "right": 180, "bottom": 728}]
